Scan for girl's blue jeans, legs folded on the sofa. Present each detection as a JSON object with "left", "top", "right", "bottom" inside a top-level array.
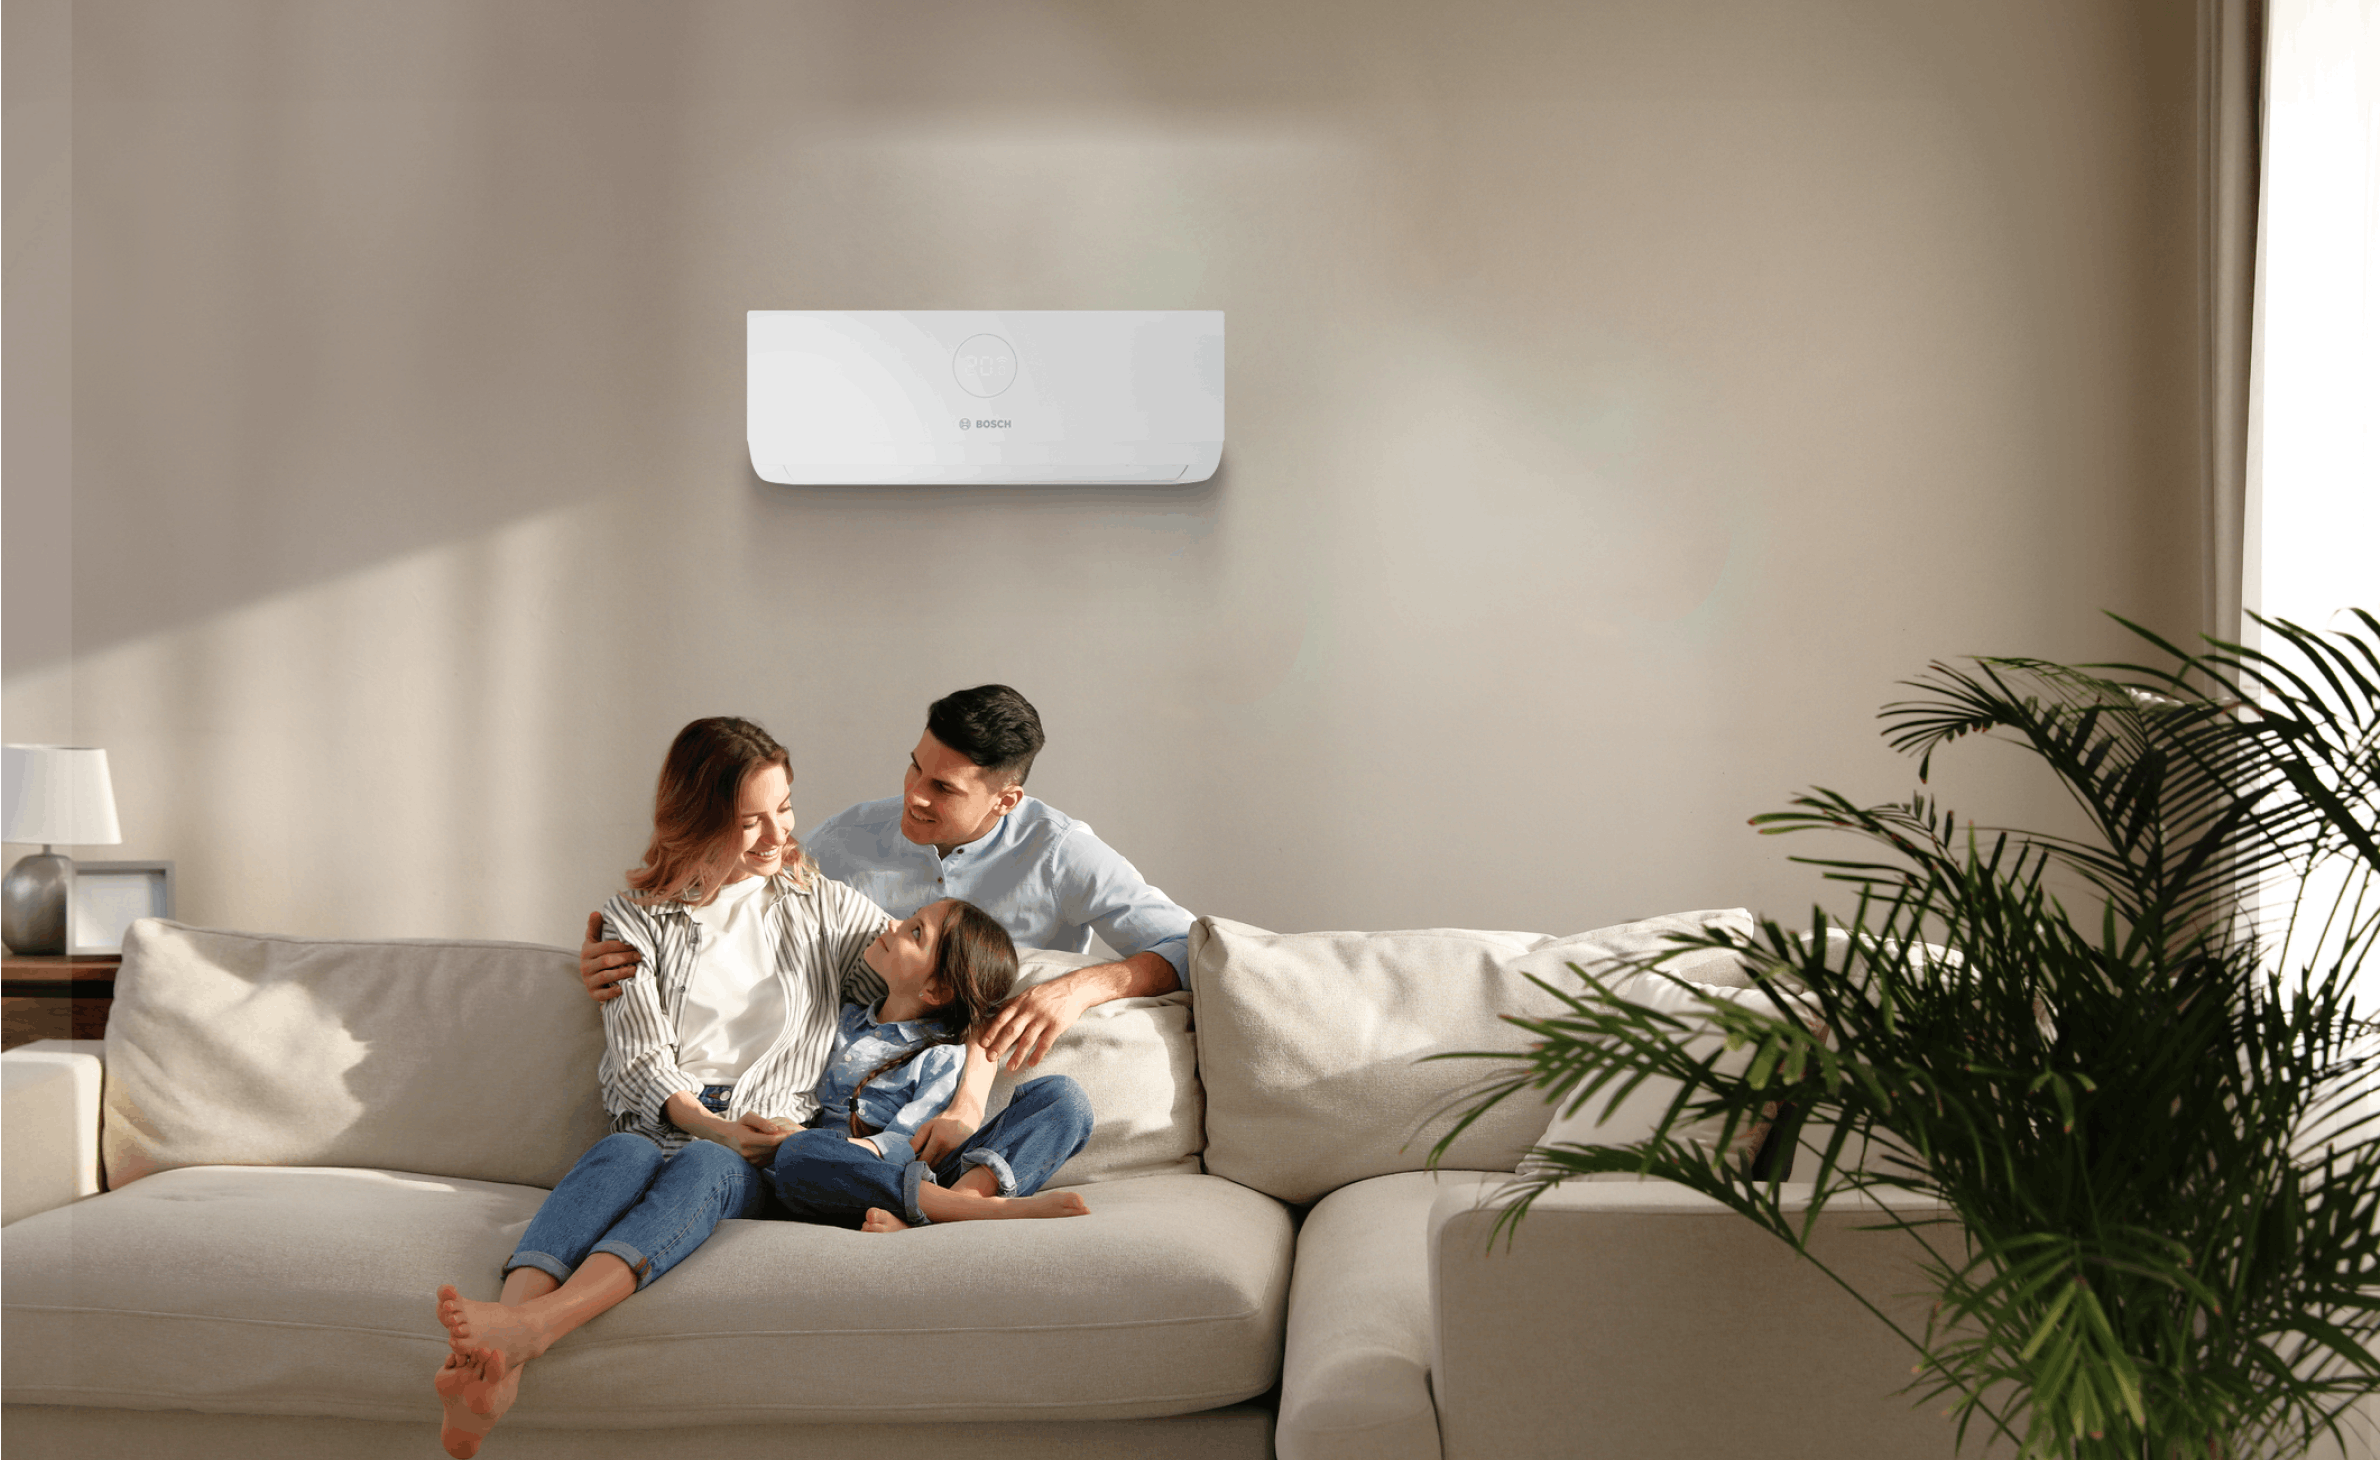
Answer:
[{"left": 769, "top": 1074, "right": 1090, "bottom": 1227}]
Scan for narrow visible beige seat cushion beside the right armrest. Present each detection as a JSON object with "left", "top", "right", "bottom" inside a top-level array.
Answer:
[{"left": 1273, "top": 1172, "right": 1511, "bottom": 1460}]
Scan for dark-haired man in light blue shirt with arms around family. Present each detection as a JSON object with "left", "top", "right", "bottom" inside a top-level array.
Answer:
[{"left": 578, "top": 684, "right": 1190, "bottom": 1162}]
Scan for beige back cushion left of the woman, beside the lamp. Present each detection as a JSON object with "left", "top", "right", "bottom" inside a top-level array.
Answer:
[{"left": 100, "top": 917, "right": 612, "bottom": 1186}]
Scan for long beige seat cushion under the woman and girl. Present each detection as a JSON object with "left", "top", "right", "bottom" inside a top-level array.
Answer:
[{"left": 0, "top": 1167, "right": 1292, "bottom": 1427}]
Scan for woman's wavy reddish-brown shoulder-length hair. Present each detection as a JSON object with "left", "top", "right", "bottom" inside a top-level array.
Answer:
[{"left": 628, "top": 715, "right": 809, "bottom": 907}]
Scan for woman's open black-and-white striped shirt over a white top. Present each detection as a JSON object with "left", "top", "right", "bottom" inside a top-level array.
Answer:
[{"left": 597, "top": 872, "right": 893, "bottom": 1150}]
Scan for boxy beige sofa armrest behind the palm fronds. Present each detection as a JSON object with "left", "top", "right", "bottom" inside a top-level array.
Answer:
[{"left": 1428, "top": 1181, "right": 1999, "bottom": 1460}]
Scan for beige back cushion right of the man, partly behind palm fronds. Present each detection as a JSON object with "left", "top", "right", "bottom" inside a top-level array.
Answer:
[{"left": 1190, "top": 912, "right": 1740, "bottom": 1203}]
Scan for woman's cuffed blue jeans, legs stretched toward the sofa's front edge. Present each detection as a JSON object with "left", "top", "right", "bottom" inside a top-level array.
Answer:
[{"left": 505, "top": 1131, "right": 769, "bottom": 1291}]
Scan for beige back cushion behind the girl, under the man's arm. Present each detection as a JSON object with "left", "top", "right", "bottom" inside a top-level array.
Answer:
[{"left": 983, "top": 948, "right": 1207, "bottom": 1186}]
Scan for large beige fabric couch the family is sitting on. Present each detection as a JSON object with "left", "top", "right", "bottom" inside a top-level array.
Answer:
[{"left": 0, "top": 915, "right": 1952, "bottom": 1460}]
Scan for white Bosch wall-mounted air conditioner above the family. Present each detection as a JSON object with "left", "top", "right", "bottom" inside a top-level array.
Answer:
[{"left": 745, "top": 310, "right": 1223, "bottom": 486}]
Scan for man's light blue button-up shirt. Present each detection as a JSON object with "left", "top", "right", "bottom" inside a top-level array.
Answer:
[{"left": 802, "top": 795, "right": 1190, "bottom": 977}]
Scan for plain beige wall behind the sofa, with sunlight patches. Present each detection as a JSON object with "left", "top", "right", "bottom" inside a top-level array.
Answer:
[{"left": 5, "top": 0, "right": 2197, "bottom": 941}]
